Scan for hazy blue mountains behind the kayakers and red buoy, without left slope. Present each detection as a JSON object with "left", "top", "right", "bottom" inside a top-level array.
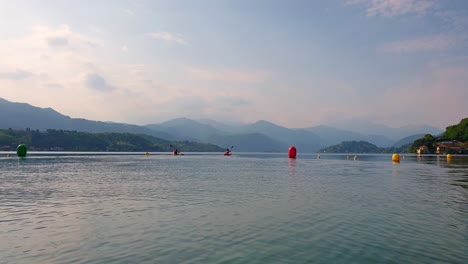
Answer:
[{"left": 146, "top": 118, "right": 440, "bottom": 152}]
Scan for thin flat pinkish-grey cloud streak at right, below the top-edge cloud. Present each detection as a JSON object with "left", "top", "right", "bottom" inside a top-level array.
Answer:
[{"left": 380, "top": 35, "right": 463, "bottom": 53}]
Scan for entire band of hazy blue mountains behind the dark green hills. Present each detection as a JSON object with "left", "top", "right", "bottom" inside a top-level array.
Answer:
[{"left": 0, "top": 98, "right": 443, "bottom": 152}]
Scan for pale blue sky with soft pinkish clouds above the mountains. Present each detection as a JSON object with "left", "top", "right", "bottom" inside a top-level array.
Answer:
[{"left": 0, "top": 0, "right": 468, "bottom": 128}]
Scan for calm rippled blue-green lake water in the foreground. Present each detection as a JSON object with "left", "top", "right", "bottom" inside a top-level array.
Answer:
[{"left": 0, "top": 153, "right": 468, "bottom": 263}]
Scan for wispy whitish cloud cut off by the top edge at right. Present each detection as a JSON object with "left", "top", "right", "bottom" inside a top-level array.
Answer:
[{"left": 345, "top": 0, "right": 435, "bottom": 17}]
